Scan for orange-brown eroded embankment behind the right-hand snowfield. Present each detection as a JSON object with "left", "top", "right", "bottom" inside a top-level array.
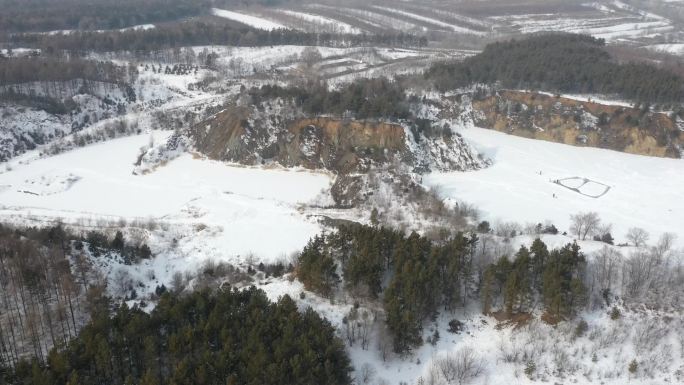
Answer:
[{"left": 473, "top": 91, "right": 684, "bottom": 158}]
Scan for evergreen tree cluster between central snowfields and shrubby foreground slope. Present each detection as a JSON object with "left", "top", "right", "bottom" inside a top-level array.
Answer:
[{"left": 297, "top": 225, "right": 586, "bottom": 354}]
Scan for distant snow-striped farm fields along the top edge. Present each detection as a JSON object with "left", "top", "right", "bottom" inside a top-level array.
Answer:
[{"left": 198, "top": 0, "right": 681, "bottom": 45}]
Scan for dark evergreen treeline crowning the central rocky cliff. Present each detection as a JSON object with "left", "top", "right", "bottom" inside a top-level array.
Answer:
[{"left": 249, "top": 78, "right": 409, "bottom": 120}]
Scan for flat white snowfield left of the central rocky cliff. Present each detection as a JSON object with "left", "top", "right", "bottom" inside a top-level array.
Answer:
[{"left": 0, "top": 132, "right": 330, "bottom": 270}]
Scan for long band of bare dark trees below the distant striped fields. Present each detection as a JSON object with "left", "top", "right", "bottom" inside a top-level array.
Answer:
[{"left": 11, "top": 19, "right": 427, "bottom": 52}]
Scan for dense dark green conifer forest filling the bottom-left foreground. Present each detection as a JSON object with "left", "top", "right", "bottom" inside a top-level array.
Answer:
[{"left": 0, "top": 287, "right": 351, "bottom": 385}]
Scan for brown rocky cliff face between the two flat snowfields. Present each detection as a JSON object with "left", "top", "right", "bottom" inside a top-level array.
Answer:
[{"left": 188, "top": 100, "right": 487, "bottom": 174}]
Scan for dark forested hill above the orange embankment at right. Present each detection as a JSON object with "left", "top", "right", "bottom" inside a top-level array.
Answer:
[{"left": 425, "top": 34, "right": 684, "bottom": 102}]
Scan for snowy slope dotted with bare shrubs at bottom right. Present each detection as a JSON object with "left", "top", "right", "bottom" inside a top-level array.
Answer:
[{"left": 258, "top": 262, "right": 684, "bottom": 385}]
